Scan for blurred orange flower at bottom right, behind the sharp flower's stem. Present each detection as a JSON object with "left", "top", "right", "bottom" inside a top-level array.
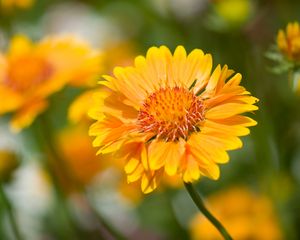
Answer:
[{"left": 190, "top": 187, "right": 283, "bottom": 240}]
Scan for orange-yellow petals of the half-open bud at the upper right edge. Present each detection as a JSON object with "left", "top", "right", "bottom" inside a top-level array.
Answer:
[{"left": 277, "top": 22, "right": 300, "bottom": 61}]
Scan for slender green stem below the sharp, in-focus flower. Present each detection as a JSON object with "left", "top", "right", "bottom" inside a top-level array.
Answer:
[{"left": 184, "top": 183, "right": 233, "bottom": 240}]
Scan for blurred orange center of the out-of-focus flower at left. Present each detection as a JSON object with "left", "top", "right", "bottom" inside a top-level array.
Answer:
[{"left": 6, "top": 56, "right": 52, "bottom": 91}]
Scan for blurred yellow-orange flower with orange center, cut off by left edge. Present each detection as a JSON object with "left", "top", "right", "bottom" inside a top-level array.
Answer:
[{"left": 0, "top": 36, "right": 101, "bottom": 131}]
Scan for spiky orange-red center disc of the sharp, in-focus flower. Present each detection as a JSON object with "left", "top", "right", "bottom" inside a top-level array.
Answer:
[{"left": 138, "top": 87, "right": 204, "bottom": 141}]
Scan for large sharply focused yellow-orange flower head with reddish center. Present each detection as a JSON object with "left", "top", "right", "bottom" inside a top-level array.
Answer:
[{"left": 89, "top": 46, "right": 257, "bottom": 193}]
